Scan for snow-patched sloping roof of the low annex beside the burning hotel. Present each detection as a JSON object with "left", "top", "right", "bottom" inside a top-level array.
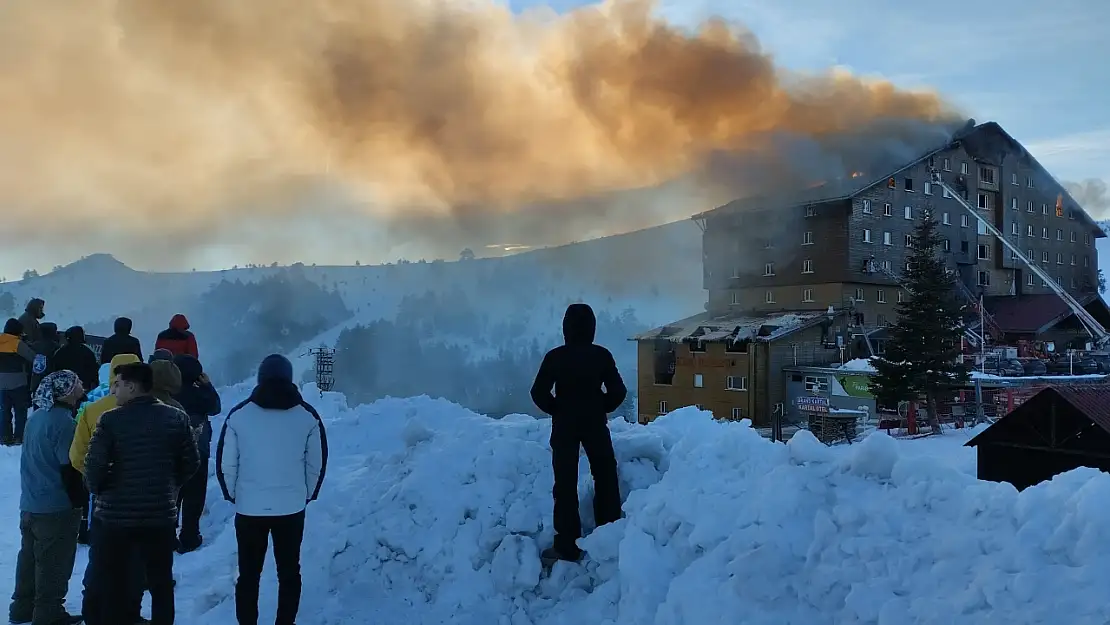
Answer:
[{"left": 630, "top": 311, "right": 842, "bottom": 343}]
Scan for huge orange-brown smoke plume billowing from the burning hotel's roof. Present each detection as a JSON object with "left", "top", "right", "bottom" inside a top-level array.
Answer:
[{"left": 0, "top": 0, "right": 962, "bottom": 267}]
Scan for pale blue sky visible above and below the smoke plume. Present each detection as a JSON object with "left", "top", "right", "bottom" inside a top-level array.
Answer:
[{"left": 0, "top": 0, "right": 1110, "bottom": 279}]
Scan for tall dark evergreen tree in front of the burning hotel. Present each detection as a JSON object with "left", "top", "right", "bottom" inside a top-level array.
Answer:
[{"left": 869, "top": 211, "right": 969, "bottom": 433}]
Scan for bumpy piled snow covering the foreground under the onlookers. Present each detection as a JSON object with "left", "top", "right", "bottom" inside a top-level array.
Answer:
[{"left": 0, "top": 386, "right": 1110, "bottom": 625}]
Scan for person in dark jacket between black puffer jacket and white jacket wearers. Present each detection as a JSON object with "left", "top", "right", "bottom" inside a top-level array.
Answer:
[{"left": 173, "top": 354, "right": 223, "bottom": 553}]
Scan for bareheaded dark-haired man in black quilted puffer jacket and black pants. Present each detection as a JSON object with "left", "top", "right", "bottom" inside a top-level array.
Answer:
[{"left": 84, "top": 363, "right": 200, "bottom": 625}]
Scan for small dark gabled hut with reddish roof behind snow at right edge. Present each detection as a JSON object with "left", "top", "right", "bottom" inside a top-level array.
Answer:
[{"left": 966, "top": 384, "right": 1110, "bottom": 491}]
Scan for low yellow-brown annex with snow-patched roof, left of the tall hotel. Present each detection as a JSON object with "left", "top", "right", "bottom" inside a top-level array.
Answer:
[{"left": 633, "top": 310, "right": 847, "bottom": 425}]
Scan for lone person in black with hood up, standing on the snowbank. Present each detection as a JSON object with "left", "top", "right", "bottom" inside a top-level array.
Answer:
[{"left": 532, "top": 303, "right": 628, "bottom": 562}]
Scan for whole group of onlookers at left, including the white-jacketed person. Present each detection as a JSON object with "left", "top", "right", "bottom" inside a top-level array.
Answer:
[{"left": 0, "top": 299, "right": 327, "bottom": 625}]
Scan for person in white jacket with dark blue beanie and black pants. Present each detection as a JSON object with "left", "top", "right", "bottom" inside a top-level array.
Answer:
[{"left": 215, "top": 354, "right": 327, "bottom": 625}]
